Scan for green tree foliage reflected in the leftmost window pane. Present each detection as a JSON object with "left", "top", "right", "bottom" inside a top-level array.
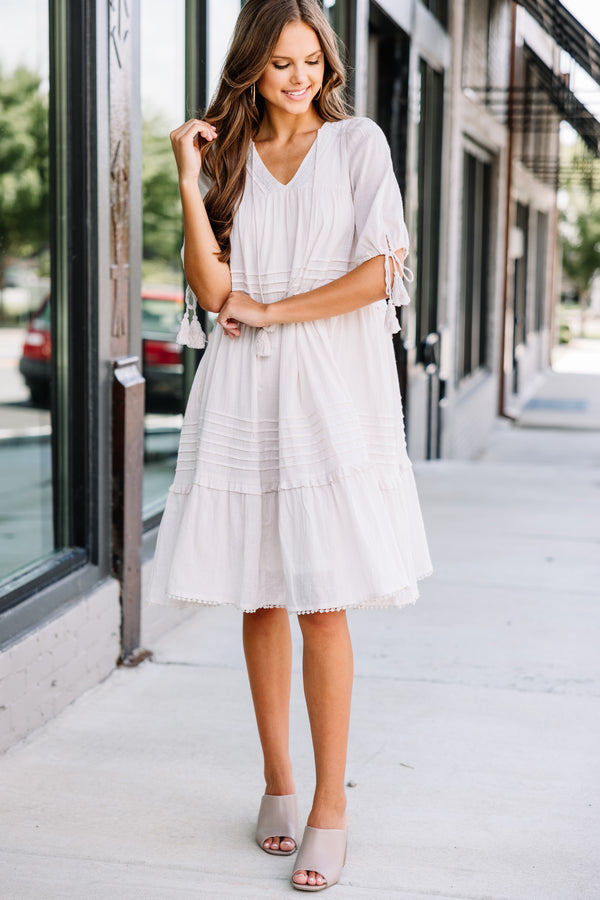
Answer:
[{"left": 0, "top": 68, "right": 49, "bottom": 266}]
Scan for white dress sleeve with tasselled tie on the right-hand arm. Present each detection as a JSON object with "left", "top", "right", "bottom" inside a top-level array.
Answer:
[{"left": 348, "top": 118, "right": 412, "bottom": 332}]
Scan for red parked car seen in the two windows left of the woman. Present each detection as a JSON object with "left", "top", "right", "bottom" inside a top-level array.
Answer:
[{"left": 19, "top": 288, "right": 183, "bottom": 409}]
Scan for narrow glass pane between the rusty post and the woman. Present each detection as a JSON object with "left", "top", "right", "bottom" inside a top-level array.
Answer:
[{"left": 141, "top": 0, "right": 185, "bottom": 518}]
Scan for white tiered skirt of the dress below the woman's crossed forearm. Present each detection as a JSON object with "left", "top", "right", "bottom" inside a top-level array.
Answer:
[{"left": 150, "top": 302, "right": 431, "bottom": 613}]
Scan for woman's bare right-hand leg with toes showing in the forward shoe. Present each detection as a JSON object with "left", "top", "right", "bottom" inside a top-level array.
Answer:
[{"left": 293, "top": 611, "right": 354, "bottom": 885}]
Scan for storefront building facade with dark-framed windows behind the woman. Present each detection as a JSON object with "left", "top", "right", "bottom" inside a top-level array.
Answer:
[{"left": 0, "top": 0, "right": 600, "bottom": 749}]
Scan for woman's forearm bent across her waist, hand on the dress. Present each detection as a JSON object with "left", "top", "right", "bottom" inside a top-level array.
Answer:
[{"left": 217, "top": 248, "right": 407, "bottom": 337}]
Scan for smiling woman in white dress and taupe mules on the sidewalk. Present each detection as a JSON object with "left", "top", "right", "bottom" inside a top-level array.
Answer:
[{"left": 151, "top": 0, "right": 431, "bottom": 891}]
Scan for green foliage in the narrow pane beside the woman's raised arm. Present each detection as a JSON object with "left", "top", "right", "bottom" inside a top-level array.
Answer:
[{"left": 142, "top": 118, "right": 182, "bottom": 271}]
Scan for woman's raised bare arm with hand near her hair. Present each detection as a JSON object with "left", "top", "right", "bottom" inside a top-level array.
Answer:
[{"left": 171, "top": 119, "right": 231, "bottom": 312}]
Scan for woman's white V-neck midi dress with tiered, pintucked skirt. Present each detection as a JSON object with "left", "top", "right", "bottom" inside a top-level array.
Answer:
[{"left": 150, "top": 118, "right": 431, "bottom": 613}]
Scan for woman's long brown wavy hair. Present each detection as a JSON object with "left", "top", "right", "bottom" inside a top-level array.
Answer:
[{"left": 201, "top": 0, "right": 348, "bottom": 262}]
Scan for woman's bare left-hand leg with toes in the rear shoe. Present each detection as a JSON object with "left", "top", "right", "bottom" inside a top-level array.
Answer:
[{"left": 243, "top": 609, "right": 296, "bottom": 851}]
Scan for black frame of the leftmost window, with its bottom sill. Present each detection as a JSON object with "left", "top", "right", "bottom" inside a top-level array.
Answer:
[{"left": 0, "top": 0, "right": 101, "bottom": 624}]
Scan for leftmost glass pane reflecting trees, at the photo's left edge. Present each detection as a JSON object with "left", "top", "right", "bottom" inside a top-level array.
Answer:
[{"left": 0, "top": 0, "right": 54, "bottom": 584}]
